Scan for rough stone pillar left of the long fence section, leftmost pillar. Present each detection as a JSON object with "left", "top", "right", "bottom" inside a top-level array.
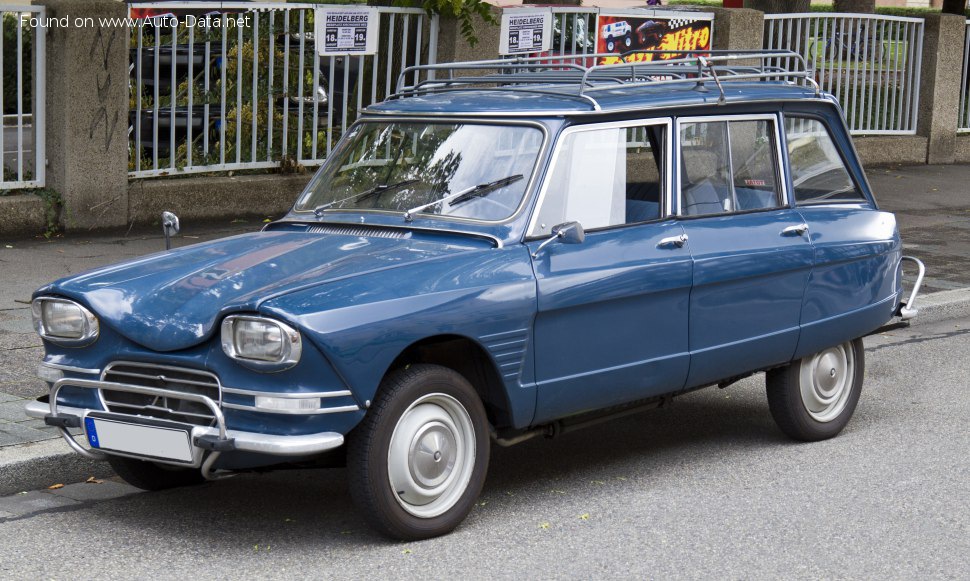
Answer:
[{"left": 35, "top": 0, "right": 129, "bottom": 230}]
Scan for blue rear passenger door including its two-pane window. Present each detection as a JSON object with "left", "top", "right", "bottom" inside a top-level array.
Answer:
[{"left": 677, "top": 115, "right": 814, "bottom": 387}]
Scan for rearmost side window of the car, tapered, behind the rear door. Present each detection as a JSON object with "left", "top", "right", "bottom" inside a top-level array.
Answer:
[{"left": 785, "top": 117, "right": 865, "bottom": 204}]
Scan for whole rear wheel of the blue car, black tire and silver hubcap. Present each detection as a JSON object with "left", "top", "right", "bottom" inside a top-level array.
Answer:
[{"left": 765, "top": 338, "right": 866, "bottom": 442}]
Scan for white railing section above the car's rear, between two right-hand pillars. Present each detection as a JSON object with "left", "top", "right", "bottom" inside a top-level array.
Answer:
[{"left": 764, "top": 13, "right": 924, "bottom": 135}]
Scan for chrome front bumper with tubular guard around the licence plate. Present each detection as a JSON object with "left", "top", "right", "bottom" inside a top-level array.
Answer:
[{"left": 25, "top": 378, "right": 344, "bottom": 479}]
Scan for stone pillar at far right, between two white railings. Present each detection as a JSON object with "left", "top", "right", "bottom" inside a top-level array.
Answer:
[{"left": 916, "top": 14, "right": 966, "bottom": 163}]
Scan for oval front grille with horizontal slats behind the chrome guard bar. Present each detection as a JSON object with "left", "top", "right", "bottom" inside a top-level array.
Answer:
[{"left": 100, "top": 362, "right": 222, "bottom": 426}]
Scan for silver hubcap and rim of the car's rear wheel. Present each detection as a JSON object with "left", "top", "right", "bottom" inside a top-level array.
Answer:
[{"left": 799, "top": 343, "right": 855, "bottom": 422}]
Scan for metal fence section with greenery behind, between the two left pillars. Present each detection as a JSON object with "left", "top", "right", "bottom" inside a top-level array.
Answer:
[{"left": 128, "top": 2, "right": 438, "bottom": 177}]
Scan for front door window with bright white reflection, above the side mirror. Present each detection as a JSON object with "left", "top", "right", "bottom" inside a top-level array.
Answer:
[{"left": 529, "top": 125, "right": 667, "bottom": 237}]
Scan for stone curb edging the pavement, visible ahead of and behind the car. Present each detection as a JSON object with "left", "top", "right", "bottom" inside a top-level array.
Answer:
[{"left": 0, "top": 288, "right": 970, "bottom": 496}]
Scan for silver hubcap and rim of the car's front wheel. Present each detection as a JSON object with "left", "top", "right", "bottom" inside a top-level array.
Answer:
[{"left": 387, "top": 393, "right": 475, "bottom": 518}]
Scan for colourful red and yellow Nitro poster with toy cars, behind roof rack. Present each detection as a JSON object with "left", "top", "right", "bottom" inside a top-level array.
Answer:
[{"left": 596, "top": 10, "right": 714, "bottom": 65}]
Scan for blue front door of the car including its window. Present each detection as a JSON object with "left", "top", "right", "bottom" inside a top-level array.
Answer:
[{"left": 528, "top": 120, "right": 691, "bottom": 423}]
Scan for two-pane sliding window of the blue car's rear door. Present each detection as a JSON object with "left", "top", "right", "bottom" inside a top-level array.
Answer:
[{"left": 680, "top": 119, "right": 782, "bottom": 216}]
